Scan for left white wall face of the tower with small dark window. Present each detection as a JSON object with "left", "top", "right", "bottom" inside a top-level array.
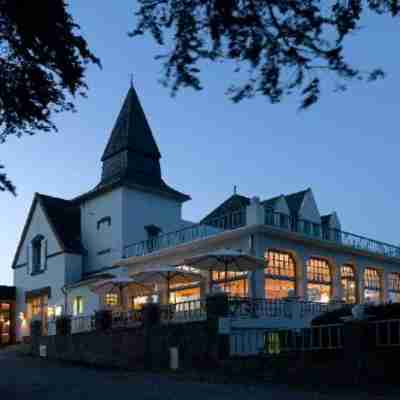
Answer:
[{"left": 81, "top": 188, "right": 123, "bottom": 272}]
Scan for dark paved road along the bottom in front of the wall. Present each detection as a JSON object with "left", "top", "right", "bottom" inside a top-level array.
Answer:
[{"left": 0, "top": 351, "right": 400, "bottom": 400}]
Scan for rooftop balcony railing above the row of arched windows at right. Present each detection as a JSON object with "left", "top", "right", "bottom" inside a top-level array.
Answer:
[{"left": 264, "top": 209, "right": 400, "bottom": 257}]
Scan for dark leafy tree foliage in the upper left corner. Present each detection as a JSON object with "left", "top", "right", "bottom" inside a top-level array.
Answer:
[{"left": 0, "top": 0, "right": 100, "bottom": 193}]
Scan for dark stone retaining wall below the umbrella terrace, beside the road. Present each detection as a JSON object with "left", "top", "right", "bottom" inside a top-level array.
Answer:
[{"left": 32, "top": 322, "right": 213, "bottom": 369}]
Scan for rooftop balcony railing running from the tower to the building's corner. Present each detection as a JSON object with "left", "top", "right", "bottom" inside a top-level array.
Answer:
[{"left": 124, "top": 209, "right": 246, "bottom": 257}]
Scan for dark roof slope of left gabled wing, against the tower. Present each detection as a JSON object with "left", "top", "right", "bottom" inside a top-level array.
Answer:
[{"left": 38, "top": 194, "right": 83, "bottom": 253}]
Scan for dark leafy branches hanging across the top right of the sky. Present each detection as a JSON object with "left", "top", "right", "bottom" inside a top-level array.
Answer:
[{"left": 131, "top": 0, "right": 400, "bottom": 109}]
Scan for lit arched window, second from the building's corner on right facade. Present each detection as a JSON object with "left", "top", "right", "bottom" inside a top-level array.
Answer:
[{"left": 307, "top": 258, "right": 332, "bottom": 303}]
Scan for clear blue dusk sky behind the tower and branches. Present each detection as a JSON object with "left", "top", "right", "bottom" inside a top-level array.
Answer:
[{"left": 0, "top": 0, "right": 400, "bottom": 284}]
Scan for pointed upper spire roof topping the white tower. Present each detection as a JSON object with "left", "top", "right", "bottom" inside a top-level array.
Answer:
[{"left": 101, "top": 86, "right": 161, "bottom": 161}]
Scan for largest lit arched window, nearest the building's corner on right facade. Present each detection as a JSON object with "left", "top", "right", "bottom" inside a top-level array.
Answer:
[{"left": 265, "top": 250, "right": 296, "bottom": 299}]
